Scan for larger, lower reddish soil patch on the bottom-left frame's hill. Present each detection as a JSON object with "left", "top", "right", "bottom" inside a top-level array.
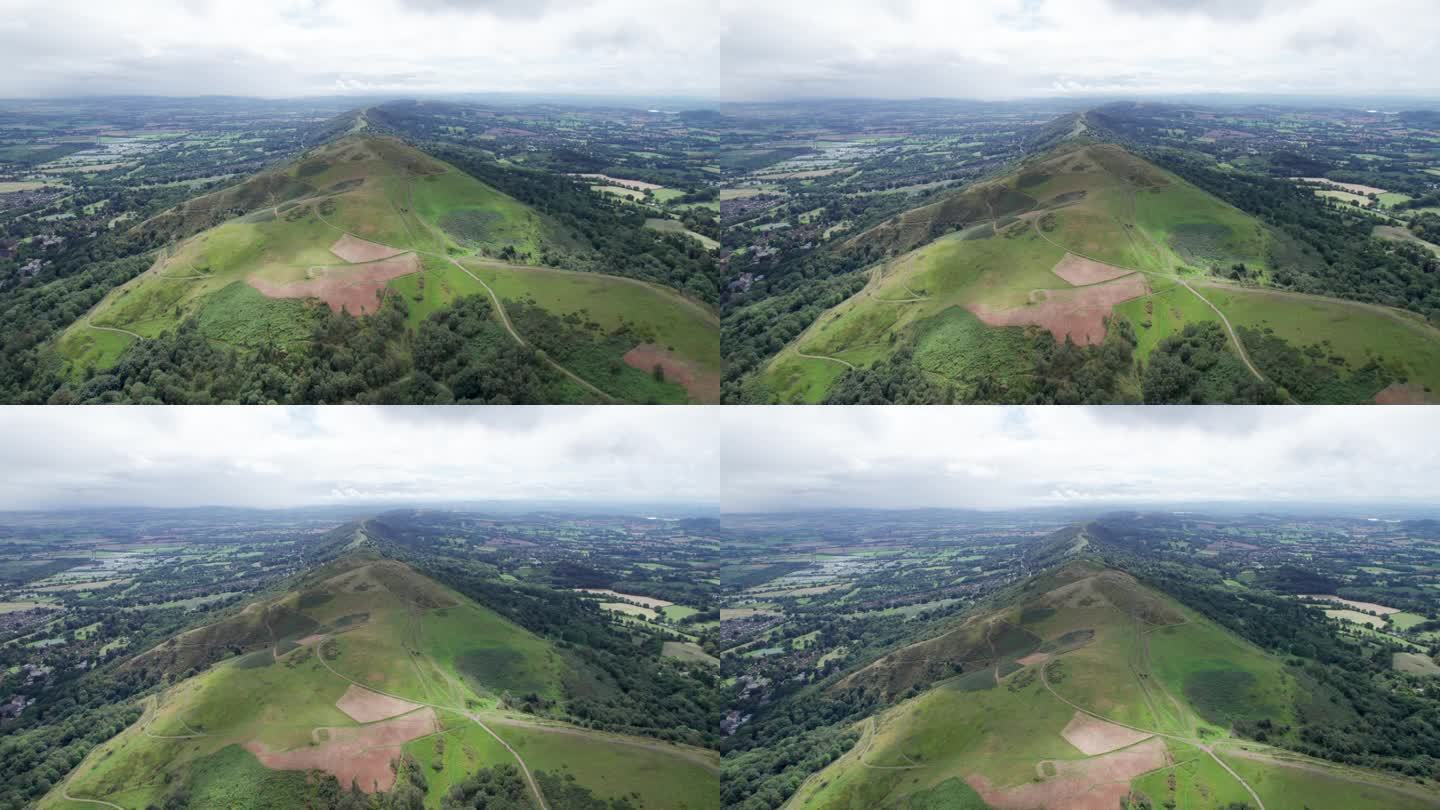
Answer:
[{"left": 245, "top": 708, "right": 439, "bottom": 793}]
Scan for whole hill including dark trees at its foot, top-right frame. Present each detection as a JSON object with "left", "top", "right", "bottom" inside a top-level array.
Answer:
[{"left": 752, "top": 140, "right": 1440, "bottom": 402}]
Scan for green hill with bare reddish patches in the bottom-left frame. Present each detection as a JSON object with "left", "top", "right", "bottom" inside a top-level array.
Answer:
[{"left": 40, "top": 547, "right": 717, "bottom": 809}]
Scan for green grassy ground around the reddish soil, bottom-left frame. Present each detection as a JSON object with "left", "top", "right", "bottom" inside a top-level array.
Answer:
[{"left": 42, "top": 556, "right": 714, "bottom": 809}]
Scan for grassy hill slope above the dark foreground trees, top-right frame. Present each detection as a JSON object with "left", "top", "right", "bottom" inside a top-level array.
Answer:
[{"left": 762, "top": 141, "right": 1440, "bottom": 402}]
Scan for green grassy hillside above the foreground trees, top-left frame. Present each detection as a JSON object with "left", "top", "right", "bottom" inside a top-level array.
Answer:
[{"left": 56, "top": 137, "right": 720, "bottom": 402}]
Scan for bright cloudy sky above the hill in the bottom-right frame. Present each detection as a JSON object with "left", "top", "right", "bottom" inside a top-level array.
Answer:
[{"left": 720, "top": 406, "right": 1440, "bottom": 512}]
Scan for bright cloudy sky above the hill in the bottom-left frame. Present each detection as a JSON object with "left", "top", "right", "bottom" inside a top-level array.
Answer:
[{"left": 0, "top": 406, "right": 719, "bottom": 510}]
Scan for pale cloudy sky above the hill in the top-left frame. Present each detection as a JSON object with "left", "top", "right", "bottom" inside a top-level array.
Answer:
[{"left": 0, "top": 0, "right": 719, "bottom": 98}]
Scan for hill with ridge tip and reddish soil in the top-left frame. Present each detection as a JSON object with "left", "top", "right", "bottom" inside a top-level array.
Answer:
[{"left": 56, "top": 131, "right": 720, "bottom": 402}]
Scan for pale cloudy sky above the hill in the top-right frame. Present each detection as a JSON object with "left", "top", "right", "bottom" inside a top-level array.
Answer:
[{"left": 720, "top": 0, "right": 1440, "bottom": 99}]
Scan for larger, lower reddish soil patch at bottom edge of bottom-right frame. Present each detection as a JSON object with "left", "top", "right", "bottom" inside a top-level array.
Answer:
[{"left": 965, "top": 736, "right": 1169, "bottom": 810}]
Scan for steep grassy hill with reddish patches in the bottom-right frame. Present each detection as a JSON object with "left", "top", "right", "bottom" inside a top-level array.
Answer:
[{"left": 786, "top": 559, "right": 1440, "bottom": 810}]
